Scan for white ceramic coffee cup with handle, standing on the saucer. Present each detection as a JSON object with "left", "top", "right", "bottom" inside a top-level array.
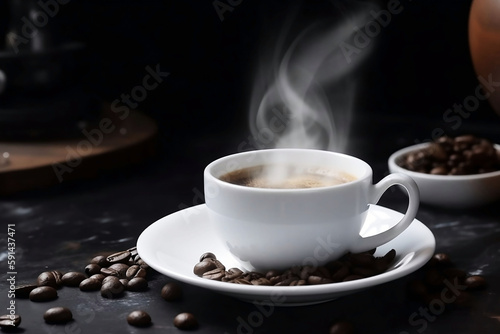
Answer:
[{"left": 204, "top": 149, "right": 419, "bottom": 271}]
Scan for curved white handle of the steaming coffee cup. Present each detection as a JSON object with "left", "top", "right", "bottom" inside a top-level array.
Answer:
[{"left": 351, "top": 173, "right": 420, "bottom": 253}]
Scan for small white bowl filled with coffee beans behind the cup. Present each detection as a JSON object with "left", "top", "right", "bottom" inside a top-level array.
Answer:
[{"left": 388, "top": 135, "right": 500, "bottom": 209}]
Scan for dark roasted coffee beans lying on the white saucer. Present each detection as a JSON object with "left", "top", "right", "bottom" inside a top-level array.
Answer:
[{"left": 193, "top": 249, "right": 396, "bottom": 286}]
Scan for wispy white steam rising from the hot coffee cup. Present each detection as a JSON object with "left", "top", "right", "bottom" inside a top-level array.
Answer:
[{"left": 249, "top": 7, "right": 370, "bottom": 152}]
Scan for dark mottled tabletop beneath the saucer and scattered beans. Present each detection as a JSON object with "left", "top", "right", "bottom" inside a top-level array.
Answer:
[{"left": 0, "top": 115, "right": 500, "bottom": 333}]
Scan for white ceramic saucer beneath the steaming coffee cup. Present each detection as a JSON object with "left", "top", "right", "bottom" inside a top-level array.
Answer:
[{"left": 137, "top": 204, "right": 436, "bottom": 306}]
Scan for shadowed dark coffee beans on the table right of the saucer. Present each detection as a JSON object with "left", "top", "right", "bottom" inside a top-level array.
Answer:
[{"left": 407, "top": 253, "right": 488, "bottom": 307}]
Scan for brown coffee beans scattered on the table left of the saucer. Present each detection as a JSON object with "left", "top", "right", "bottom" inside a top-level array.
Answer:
[{"left": 6, "top": 247, "right": 198, "bottom": 329}]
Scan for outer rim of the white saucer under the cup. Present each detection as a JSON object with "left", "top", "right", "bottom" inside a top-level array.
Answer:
[{"left": 137, "top": 204, "right": 436, "bottom": 304}]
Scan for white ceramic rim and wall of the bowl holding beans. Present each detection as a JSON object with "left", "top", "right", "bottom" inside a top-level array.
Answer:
[{"left": 389, "top": 143, "right": 500, "bottom": 209}]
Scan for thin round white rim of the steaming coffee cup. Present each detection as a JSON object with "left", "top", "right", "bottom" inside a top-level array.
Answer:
[{"left": 203, "top": 148, "right": 373, "bottom": 193}]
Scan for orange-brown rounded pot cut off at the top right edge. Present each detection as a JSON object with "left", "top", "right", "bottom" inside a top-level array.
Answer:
[{"left": 469, "top": 0, "right": 500, "bottom": 114}]
